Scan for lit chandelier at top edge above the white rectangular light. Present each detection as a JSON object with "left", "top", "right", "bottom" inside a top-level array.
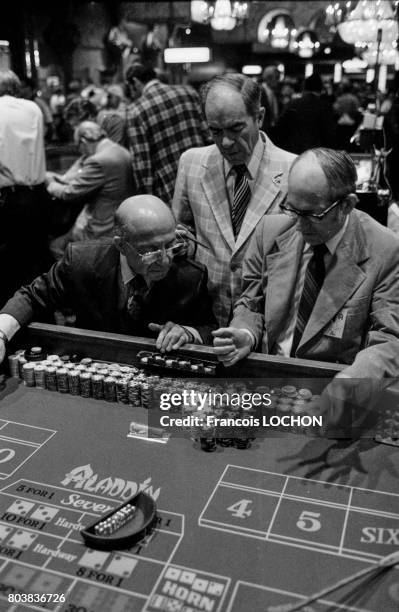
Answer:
[{"left": 191, "top": 0, "right": 248, "bottom": 30}]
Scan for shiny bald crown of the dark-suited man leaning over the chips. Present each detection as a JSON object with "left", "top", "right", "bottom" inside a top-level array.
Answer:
[{"left": 115, "top": 194, "right": 175, "bottom": 242}]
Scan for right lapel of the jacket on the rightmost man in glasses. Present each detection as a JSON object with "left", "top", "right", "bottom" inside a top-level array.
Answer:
[{"left": 298, "top": 213, "right": 369, "bottom": 350}]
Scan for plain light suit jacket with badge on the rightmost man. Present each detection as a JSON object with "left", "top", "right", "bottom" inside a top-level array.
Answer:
[{"left": 231, "top": 210, "right": 399, "bottom": 378}]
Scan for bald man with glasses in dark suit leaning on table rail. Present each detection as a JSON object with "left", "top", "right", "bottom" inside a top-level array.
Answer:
[{"left": 0, "top": 195, "right": 216, "bottom": 362}]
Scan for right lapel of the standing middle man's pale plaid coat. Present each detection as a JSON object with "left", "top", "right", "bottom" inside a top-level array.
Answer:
[{"left": 235, "top": 139, "right": 283, "bottom": 251}]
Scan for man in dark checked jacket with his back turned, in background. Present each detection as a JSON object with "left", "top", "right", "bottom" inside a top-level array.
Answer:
[{"left": 126, "top": 64, "right": 211, "bottom": 205}]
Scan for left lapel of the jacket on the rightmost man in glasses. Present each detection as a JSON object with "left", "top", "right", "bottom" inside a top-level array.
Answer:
[{"left": 265, "top": 225, "right": 303, "bottom": 350}]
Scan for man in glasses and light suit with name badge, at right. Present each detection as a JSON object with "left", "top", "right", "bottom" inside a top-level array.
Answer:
[{"left": 214, "top": 149, "right": 399, "bottom": 379}]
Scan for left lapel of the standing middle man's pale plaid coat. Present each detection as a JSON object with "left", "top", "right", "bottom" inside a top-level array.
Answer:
[{"left": 202, "top": 148, "right": 235, "bottom": 251}]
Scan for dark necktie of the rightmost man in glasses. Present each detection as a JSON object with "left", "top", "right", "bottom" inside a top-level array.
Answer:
[{"left": 291, "top": 244, "right": 327, "bottom": 357}]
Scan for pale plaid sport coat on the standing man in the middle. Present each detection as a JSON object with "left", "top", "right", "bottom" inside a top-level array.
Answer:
[{"left": 172, "top": 132, "right": 295, "bottom": 326}]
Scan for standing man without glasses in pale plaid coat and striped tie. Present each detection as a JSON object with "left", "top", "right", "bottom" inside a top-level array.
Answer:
[{"left": 172, "top": 74, "right": 295, "bottom": 325}]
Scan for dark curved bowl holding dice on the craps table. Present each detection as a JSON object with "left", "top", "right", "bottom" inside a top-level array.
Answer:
[{"left": 80, "top": 491, "right": 157, "bottom": 550}]
